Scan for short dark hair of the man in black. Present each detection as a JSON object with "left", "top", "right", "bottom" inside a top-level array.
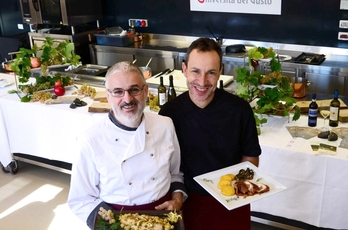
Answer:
[{"left": 185, "top": 37, "right": 222, "bottom": 69}]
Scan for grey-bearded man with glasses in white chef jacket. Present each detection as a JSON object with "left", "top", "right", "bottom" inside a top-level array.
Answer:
[{"left": 68, "top": 62, "right": 186, "bottom": 228}]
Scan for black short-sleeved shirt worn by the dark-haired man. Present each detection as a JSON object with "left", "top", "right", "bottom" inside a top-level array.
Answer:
[{"left": 159, "top": 89, "right": 261, "bottom": 195}]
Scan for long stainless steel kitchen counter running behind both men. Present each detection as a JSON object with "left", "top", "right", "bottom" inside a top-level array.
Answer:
[{"left": 90, "top": 34, "right": 348, "bottom": 96}]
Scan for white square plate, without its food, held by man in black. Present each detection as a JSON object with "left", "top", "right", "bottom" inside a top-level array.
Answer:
[{"left": 193, "top": 162, "right": 287, "bottom": 210}]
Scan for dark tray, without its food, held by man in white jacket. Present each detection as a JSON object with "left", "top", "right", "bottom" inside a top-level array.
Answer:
[{"left": 93, "top": 210, "right": 185, "bottom": 230}]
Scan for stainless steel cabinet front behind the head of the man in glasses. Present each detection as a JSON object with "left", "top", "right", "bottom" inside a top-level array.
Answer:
[{"left": 89, "top": 44, "right": 181, "bottom": 75}]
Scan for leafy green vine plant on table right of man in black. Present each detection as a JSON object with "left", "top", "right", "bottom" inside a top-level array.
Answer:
[{"left": 236, "top": 47, "right": 300, "bottom": 133}]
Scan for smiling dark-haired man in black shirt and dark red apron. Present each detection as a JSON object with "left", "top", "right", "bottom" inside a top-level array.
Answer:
[{"left": 159, "top": 38, "right": 261, "bottom": 230}]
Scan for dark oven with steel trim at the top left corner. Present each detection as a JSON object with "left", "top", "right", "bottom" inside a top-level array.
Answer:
[{"left": 20, "top": 0, "right": 102, "bottom": 26}]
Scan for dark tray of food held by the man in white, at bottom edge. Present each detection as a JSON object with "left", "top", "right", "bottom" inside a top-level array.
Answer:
[{"left": 93, "top": 208, "right": 185, "bottom": 230}]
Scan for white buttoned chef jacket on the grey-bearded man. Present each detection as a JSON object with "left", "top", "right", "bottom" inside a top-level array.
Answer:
[{"left": 68, "top": 112, "right": 183, "bottom": 222}]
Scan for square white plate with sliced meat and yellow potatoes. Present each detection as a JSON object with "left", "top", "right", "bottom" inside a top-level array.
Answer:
[{"left": 193, "top": 162, "right": 287, "bottom": 210}]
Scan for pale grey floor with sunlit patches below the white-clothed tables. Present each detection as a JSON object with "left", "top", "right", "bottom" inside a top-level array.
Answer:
[{"left": 0, "top": 162, "right": 281, "bottom": 230}]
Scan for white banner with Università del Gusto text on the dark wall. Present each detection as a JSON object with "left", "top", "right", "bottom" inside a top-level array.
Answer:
[{"left": 190, "top": 0, "right": 282, "bottom": 15}]
